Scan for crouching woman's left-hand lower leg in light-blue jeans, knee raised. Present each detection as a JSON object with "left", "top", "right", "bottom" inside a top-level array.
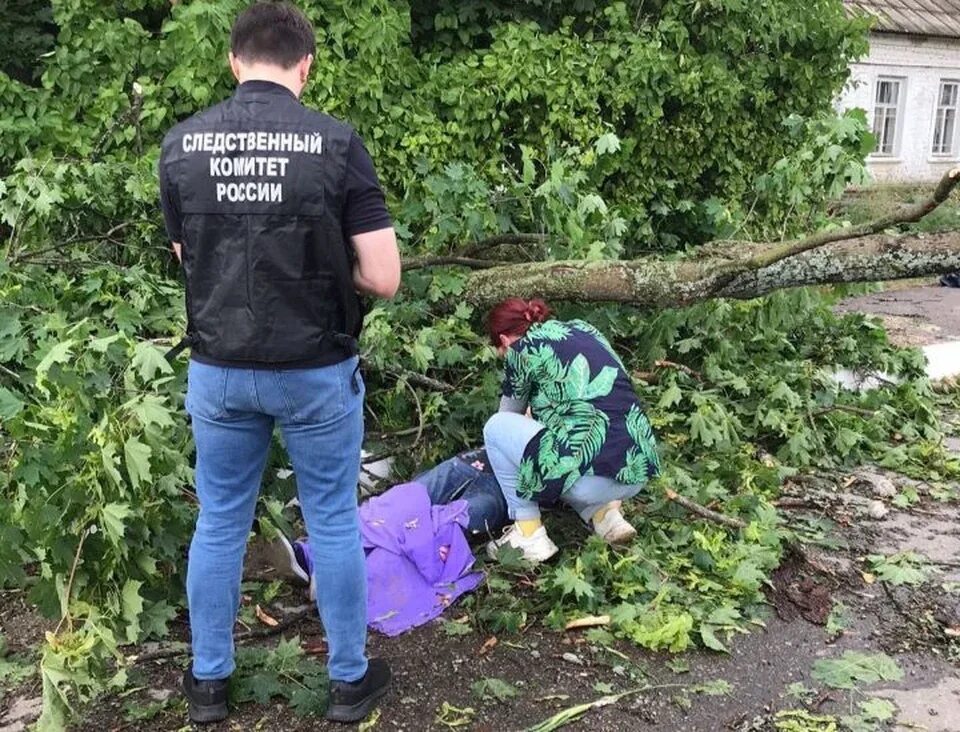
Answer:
[{"left": 483, "top": 412, "right": 544, "bottom": 521}]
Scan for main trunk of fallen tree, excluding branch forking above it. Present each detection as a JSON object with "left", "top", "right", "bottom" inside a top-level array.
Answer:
[{"left": 467, "top": 231, "right": 960, "bottom": 308}]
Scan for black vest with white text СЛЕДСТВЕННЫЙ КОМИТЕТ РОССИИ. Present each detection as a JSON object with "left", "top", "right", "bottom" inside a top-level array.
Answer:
[{"left": 160, "top": 81, "right": 362, "bottom": 368}]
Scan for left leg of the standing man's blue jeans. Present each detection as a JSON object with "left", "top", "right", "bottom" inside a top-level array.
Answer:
[{"left": 187, "top": 361, "right": 273, "bottom": 680}]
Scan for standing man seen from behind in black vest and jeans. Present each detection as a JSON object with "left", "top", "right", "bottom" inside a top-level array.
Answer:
[{"left": 160, "top": 3, "right": 400, "bottom": 722}]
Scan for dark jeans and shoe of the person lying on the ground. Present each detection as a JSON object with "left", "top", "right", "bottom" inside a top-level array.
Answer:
[{"left": 269, "top": 449, "right": 507, "bottom": 600}]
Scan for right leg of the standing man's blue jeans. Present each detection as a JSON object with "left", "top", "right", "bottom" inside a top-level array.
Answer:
[{"left": 274, "top": 358, "right": 367, "bottom": 682}]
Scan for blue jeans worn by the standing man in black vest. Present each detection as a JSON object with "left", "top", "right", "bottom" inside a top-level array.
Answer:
[{"left": 186, "top": 358, "right": 367, "bottom": 681}]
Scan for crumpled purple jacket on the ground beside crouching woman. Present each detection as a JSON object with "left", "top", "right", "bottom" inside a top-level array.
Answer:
[{"left": 360, "top": 483, "right": 483, "bottom": 636}]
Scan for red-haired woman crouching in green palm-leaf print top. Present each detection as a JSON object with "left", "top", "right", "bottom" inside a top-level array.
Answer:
[{"left": 483, "top": 298, "right": 660, "bottom": 562}]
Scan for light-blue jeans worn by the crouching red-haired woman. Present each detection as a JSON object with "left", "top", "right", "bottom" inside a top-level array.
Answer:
[{"left": 483, "top": 412, "right": 643, "bottom": 523}]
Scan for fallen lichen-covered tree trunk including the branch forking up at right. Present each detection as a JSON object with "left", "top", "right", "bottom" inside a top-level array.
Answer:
[{"left": 467, "top": 168, "right": 960, "bottom": 308}]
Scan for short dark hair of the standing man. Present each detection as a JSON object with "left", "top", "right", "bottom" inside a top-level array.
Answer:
[{"left": 230, "top": 2, "right": 317, "bottom": 69}]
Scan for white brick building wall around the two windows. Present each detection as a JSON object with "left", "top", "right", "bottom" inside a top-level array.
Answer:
[{"left": 837, "top": 33, "right": 960, "bottom": 183}]
